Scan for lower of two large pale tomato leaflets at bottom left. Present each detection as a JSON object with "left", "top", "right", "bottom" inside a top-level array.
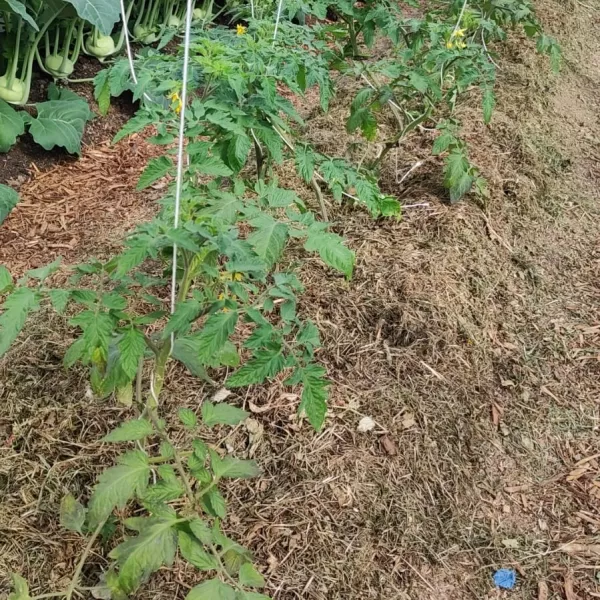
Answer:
[{"left": 109, "top": 514, "right": 177, "bottom": 594}]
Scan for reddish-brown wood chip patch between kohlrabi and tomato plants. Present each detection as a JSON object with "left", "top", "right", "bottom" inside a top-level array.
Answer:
[{"left": 0, "top": 134, "right": 164, "bottom": 276}]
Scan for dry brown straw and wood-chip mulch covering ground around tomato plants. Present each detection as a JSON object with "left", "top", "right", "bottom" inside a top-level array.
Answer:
[{"left": 0, "top": 0, "right": 600, "bottom": 600}]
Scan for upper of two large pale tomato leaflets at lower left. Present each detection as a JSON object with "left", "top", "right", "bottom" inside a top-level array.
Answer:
[{"left": 89, "top": 450, "right": 150, "bottom": 527}]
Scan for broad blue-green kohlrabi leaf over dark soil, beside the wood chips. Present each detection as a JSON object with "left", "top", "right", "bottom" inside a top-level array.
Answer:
[{"left": 27, "top": 98, "right": 93, "bottom": 154}]
